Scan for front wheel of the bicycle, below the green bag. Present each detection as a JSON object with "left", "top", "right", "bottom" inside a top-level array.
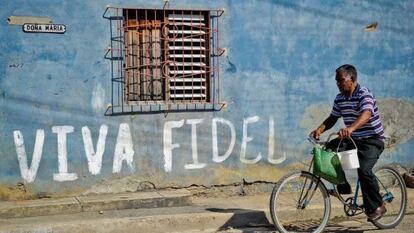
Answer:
[{"left": 270, "top": 171, "right": 331, "bottom": 233}]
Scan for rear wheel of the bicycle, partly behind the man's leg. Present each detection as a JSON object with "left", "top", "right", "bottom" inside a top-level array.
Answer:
[{"left": 372, "top": 166, "right": 407, "bottom": 229}]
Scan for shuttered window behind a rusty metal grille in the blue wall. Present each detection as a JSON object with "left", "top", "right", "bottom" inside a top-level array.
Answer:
[{"left": 104, "top": 8, "right": 223, "bottom": 115}]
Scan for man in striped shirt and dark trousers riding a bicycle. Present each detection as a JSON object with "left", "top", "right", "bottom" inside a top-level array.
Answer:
[{"left": 311, "top": 64, "right": 387, "bottom": 221}]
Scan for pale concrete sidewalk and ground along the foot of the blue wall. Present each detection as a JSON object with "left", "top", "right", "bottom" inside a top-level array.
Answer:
[{"left": 0, "top": 189, "right": 414, "bottom": 233}]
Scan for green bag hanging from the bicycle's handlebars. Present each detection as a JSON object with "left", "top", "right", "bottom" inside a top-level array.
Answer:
[{"left": 312, "top": 147, "right": 346, "bottom": 184}]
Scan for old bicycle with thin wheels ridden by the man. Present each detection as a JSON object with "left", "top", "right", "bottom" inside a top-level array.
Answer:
[{"left": 270, "top": 134, "right": 407, "bottom": 233}]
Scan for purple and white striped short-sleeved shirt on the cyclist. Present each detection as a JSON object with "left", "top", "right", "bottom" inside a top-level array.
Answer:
[{"left": 331, "top": 84, "right": 385, "bottom": 139}]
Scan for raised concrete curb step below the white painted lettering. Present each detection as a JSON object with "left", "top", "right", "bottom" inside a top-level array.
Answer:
[{"left": 0, "top": 190, "right": 191, "bottom": 218}]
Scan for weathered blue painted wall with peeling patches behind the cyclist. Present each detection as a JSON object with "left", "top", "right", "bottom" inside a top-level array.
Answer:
[{"left": 0, "top": 0, "right": 414, "bottom": 193}]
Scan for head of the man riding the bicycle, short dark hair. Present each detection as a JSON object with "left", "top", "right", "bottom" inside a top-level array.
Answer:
[{"left": 335, "top": 64, "right": 358, "bottom": 95}]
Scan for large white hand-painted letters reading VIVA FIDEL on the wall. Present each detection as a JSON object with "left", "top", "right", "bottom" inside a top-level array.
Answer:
[{"left": 13, "top": 116, "right": 286, "bottom": 183}]
